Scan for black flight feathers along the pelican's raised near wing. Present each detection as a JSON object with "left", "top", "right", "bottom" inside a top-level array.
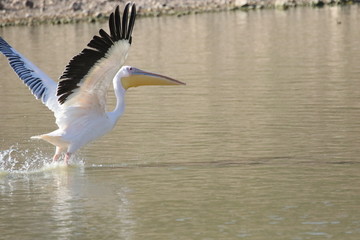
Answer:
[{"left": 57, "top": 3, "right": 136, "bottom": 104}]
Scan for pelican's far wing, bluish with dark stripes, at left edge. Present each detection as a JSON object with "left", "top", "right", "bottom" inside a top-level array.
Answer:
[{"left": 0, "top": 37, "right": 59, "bottom": 112}]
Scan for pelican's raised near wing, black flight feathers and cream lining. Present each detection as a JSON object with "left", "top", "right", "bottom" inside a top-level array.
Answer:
[{"left": 57, "top": 3, "right": 136, "bottom": 111}]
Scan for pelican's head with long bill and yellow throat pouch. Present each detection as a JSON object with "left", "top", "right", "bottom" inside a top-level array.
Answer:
[{"left": 120, "top": 66, "right": 185, "bottom": 90}]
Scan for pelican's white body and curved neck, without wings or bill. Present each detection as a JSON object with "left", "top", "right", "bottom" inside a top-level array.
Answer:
[{"left": 32, "top": 69, "right": 127, "bottom": 154}]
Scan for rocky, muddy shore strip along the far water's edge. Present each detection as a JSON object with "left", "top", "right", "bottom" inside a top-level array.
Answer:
[{"left": 0, "top": 0, "right": 360, "bottom": 27}]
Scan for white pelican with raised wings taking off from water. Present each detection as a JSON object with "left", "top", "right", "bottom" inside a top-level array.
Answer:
[{"left": 0, "top": 3, "right": 185, "bottom": 164}]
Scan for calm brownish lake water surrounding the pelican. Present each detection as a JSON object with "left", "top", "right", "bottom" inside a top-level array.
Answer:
[{"left": 0, "top": 5, "right": 360, "bottom": 240}]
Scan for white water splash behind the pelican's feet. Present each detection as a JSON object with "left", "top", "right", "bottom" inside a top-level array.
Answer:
[{"left": 0, "top": 144, "right": 84, "bottom": 174}]
